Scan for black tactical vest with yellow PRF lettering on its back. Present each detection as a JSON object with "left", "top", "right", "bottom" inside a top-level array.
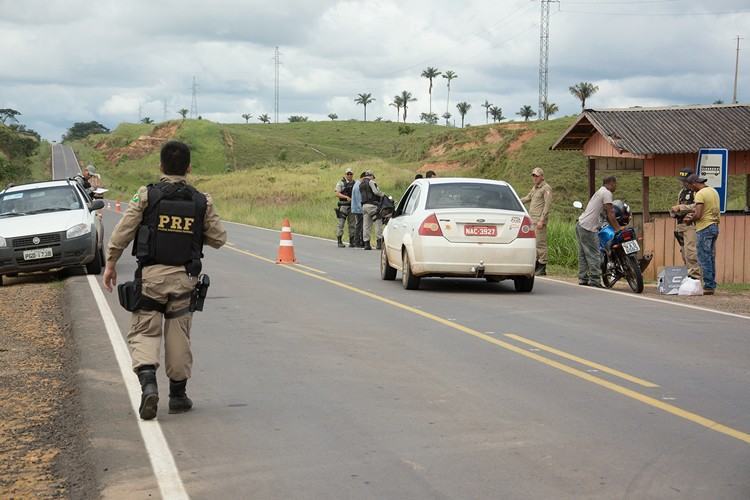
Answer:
[{"left": 133, "top": 182, "right": 207, "bottom": 276}]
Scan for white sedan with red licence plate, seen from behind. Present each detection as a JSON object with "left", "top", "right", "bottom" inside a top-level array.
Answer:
[{"left": 380, "top": 178, "right": 536, "bottom": 292}]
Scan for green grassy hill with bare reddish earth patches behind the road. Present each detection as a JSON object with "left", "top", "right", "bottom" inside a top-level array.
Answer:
[{"left": 72, "top": 117, "right": 744, "bottom": 237}]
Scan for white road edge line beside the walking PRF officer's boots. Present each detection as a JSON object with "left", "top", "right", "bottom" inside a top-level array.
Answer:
[{"left": 86, "top": 275, "right": 190, "bottom": 500}]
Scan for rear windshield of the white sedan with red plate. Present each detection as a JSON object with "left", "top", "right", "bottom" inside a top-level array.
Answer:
[{"left": 425, "top": 182, "right": 523, "bottom": 212}]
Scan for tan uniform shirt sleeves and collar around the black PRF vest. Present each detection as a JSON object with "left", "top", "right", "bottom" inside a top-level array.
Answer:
[{"left": 107, "top": 175, "right": 227, "bottom": 263}]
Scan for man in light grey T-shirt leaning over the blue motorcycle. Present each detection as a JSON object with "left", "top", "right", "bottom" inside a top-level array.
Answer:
[{"left": 576, "top": 175, "right": 622, "bottom": 288}]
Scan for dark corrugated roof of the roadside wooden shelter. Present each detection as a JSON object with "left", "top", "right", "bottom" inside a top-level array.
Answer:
[{"left": 550, "top": 104, "right": 750, "bottom": 155}]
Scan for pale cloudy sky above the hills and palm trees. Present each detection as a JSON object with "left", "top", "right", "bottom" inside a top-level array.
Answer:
[{"left": 0, "top": 0, "right": 750, "bottom": 139}]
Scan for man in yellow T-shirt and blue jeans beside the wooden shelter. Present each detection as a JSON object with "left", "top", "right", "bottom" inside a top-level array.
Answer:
[{"left": 685, "top": 174, "right": 721, "bottom": 295}]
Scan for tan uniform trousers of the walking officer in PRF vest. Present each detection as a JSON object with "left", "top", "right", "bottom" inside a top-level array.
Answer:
[{"left": 128, "top": 264, "right": 197, "bottom": 380}]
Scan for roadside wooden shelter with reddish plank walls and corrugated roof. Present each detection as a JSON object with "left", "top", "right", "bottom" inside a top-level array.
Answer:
[{"left": 550, "top": 104, "right": 750, "bottom": 283}]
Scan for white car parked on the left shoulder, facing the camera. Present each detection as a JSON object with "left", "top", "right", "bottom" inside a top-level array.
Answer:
[{"left": 0, "top": 180, "right": 104, "bottom": 285}]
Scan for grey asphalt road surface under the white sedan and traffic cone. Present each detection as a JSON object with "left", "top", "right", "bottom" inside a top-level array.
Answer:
[{"left": 54, "top": 147, "right": 750, "bottom": 499}]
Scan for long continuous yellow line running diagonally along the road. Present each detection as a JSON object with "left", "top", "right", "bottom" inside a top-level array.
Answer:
[{"left": 229, "top": 247, "right": 750, "bottom": 444}]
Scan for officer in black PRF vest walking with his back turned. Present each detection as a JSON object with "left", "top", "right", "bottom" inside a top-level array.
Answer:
[{"left": 104, "top": 141, "right": 227, "bottom": 420}]
